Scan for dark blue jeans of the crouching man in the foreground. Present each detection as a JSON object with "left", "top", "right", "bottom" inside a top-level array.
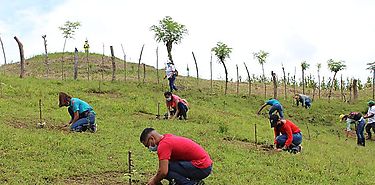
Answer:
[{"left": 166, "top": 161, "right": 212, "bottom": 185}]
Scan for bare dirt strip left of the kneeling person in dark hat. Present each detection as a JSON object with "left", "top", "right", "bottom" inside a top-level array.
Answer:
[{"left": 223, "top": 137, "right": 274, "bottom": 153}]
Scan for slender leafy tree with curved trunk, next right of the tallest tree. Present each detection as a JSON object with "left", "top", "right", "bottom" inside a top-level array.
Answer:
[{"left": 211, "top": 42, "right": 232, "bottom": 94}]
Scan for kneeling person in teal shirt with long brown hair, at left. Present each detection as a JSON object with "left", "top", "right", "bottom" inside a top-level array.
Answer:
[{"left": 59, "top": 92, "right": 97, "bottom": 132}]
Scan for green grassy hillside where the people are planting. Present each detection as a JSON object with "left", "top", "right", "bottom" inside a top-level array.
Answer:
[{"left": 0, "top": 52, "right": 375, "bottom": 185}]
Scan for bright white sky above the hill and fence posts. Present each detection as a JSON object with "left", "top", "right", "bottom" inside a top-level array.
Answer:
[{"left": 0, "top": 0, "right": 375, "bottom": 80}]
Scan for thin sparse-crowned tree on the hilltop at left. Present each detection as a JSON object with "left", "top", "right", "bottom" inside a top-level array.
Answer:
[{"left": 59, "top": 21, "right": 81, "bottom": 79}]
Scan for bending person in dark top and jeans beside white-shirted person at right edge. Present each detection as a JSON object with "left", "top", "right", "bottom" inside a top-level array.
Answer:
[{"left": 340, "top": 112, "right": 366, "bottom": 146}]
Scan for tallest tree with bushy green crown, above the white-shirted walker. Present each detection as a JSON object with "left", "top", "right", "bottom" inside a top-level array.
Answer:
[{"left": 150, "top": 16, "right": 188, "bottom": 63}]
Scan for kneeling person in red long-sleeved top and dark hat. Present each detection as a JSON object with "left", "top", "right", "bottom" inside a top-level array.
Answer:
[{"left": 270, "top": 114, "right": 302, "bottom": 153}]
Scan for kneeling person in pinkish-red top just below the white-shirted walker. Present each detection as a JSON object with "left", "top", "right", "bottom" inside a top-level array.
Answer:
[{"left": 164, "top": 92, "right": 189, "bottom": 120}]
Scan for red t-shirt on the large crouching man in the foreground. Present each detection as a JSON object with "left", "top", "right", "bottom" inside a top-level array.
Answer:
[{"left": 158, "top": 134, "right": 212, "bottom": 169}]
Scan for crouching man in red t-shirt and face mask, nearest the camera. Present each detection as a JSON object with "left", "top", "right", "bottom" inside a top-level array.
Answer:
[{"left": 140, "top": 128, "right": 212, "bottom": 185}]
